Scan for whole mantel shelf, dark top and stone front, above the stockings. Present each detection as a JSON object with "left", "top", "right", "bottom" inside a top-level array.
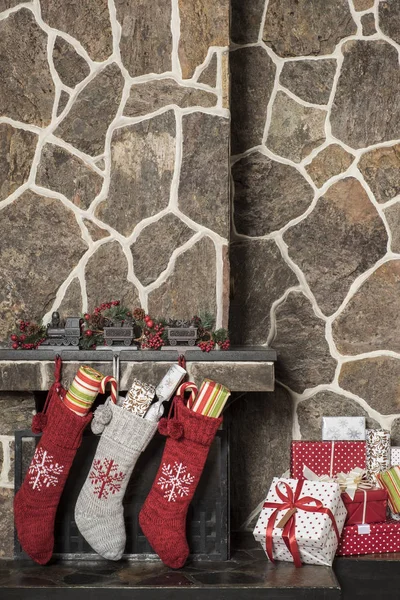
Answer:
[{"left": 0, "top": 346, "right": 277, "bottom": 392}]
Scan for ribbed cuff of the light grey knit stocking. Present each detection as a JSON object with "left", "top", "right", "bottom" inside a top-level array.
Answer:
[{"left": 103, "top": 402, "right": 158, "bottom": 452}]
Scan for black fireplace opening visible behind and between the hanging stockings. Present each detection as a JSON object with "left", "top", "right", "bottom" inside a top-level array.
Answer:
[{"left": 15, "top": 393, "right": 229, "bottom": 561}]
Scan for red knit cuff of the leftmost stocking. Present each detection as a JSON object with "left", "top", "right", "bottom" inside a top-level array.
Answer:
[{"left": 43, "top": 394, "right": 92, "bottom": 450}]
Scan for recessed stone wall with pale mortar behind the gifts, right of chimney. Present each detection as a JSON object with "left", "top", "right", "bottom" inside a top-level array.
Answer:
[{"left": 230, "top": 0, "right": 400, "bottom": 525}]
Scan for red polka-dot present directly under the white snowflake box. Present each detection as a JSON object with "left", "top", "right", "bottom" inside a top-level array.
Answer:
[{"left": 290, "top": 441, "right": 367, "bottom": 479}]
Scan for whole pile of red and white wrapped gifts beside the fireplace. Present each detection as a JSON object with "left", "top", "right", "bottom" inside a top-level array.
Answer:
[{"left": 254, "top": 417, "right": 400, "bottom": 566}]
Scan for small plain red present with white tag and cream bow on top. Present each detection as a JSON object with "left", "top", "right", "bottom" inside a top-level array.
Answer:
[{"left": 342, "top": 488, "right": 388, "bottom": 525}]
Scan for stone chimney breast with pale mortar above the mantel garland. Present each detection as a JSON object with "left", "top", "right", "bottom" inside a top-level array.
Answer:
[{"left": 0, "top": 0, "right": 229, "bottom": 340}]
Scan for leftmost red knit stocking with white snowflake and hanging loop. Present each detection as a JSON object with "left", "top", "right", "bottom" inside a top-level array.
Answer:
[{"left": 14, "top": 358, "right": 92, "bottom": 565}]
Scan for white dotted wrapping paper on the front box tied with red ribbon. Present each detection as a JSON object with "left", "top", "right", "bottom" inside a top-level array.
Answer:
[{"left": 253, "top": 477, "right": 346, "bottom": 566}]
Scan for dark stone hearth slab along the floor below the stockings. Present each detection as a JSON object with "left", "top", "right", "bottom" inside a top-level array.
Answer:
[{"left": 0, "top": 539, "right": 341, "bottom": 600}]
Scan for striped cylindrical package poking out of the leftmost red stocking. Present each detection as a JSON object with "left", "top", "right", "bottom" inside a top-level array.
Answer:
[{"left": 64, "top": 365, "right": 104, "bottom": 417}]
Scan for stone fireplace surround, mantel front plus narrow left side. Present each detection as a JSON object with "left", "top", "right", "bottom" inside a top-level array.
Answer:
[{"left": 0, "top": 348, "right": 276, "bottom": 558}]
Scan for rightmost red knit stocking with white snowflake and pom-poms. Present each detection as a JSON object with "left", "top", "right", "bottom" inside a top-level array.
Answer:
[{"left": 139, "top": 396, "right": 222, "bottom": 569}]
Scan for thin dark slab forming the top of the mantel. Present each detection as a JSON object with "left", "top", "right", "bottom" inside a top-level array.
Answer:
[{"left": 0, "top": 346, "right": 277, "bottom": 362}]
